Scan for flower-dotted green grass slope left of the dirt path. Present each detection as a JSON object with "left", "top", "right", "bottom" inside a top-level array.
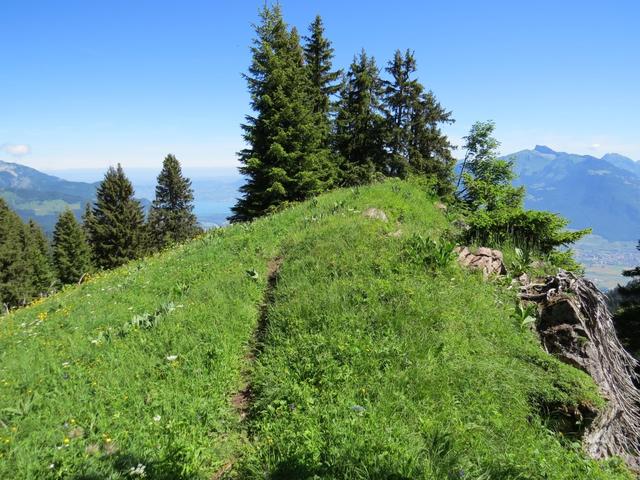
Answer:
[{"left": 0, "top": 219, "right": 284, "bottom": 479}]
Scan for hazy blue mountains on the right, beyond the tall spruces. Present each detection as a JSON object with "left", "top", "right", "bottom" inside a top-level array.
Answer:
[{"left": 503, "top": 145, "right": 640, "bottom": 241}]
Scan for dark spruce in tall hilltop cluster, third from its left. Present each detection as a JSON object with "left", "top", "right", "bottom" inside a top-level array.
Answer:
[{"left": 334, "top": 50, "right": 387, "bottom": 185}]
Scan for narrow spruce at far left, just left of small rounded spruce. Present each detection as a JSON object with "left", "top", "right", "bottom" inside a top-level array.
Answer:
[{"left": 24, "top": 220, "right": 55, "bottom": 298}]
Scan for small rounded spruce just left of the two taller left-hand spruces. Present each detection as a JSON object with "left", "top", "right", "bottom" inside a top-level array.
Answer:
[{"left": 53, "top": 209, "right": 91, "bottom": 284}]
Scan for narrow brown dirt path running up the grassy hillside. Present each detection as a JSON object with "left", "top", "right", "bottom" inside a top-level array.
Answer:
[{"left": 211, "top": 255, "right": 284, "bottom": 480}]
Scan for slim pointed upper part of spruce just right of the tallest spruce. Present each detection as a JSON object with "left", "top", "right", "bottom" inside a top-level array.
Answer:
[{"left": 304, "top": 15, "right": 342, "bottom": 118}]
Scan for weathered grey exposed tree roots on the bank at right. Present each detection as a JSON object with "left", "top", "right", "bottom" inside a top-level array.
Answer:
[{"left": 520, "top": 271, "right": 640, "bottom": 471}]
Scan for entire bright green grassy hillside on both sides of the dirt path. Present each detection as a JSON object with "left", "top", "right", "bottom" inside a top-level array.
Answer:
[{"left": 0, "top": 180, "right": 630, "bottom": 480}]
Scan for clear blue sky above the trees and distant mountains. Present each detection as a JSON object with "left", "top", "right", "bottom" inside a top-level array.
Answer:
[{"left": 0, "top": 0, "right": 640, "bottom": 169}]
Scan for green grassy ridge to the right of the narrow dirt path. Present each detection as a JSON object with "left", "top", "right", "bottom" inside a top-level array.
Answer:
[{"left": 238, "top": 184, "right": 625, "bottom": 479}]
